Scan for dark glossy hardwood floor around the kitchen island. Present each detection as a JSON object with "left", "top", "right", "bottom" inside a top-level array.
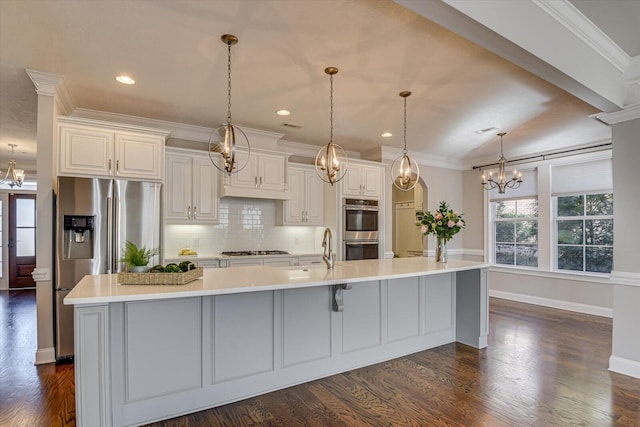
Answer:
[{"left": 0, "top": 291, "right": 640, "bottom": 427}]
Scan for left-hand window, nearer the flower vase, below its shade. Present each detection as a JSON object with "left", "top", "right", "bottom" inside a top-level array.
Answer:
[{"left": 492, "top": 198, "right": 538, "bottom": 267}]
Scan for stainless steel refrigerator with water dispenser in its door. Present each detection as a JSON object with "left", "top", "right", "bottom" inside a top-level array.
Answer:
[{"left": 54, "top": 177, "right": 161, "bottom": 360}]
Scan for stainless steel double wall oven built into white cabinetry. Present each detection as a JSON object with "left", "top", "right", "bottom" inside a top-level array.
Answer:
[{"left": 342, "top": 199, "right": 379, "bottom": 261}]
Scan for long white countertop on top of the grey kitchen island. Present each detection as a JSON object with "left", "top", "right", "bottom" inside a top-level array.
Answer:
[{"left": 64, "top": 257, "right": 489, "bottom": 305}]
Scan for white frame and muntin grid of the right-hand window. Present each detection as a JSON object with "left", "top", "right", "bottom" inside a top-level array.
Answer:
[{"left": 551, "top": 190, "right": 615, "bottom": 277}]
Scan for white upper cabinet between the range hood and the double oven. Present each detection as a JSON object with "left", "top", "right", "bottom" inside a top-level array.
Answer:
[{"left": 281, "top": 164, "right": 324, "bottom": 225}]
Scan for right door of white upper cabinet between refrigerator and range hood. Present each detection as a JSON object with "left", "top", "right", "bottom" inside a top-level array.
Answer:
[{"left": 192, "top": 157, "right": 218, "bottom": 223}]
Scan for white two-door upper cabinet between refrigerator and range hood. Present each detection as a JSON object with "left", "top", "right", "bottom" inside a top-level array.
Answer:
[{"left": 164, "top": 150, "right": 219, "bottom": 224}]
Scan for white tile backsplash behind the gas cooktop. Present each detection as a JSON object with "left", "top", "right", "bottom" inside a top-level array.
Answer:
[{"left": 164, "top": 197, "right": 324, "bottom": 258}]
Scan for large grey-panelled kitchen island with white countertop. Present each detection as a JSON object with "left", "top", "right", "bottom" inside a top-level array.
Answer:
[{"left": 65, "top": 257, "right": 488, "bottom": 426}]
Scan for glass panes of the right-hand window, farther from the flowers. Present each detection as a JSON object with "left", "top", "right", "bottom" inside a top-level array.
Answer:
[{"left": 556, "top": 193, "right": 613, "bottom": 273}]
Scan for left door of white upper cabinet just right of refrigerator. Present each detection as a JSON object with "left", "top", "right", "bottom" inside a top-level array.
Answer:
[{"left": 164, "top": 155, "right": 191, "bottom": 222}]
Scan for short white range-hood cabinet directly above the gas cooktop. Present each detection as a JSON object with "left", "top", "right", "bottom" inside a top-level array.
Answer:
[{"left": 220, "top": 149, "right": 289, "bottom": 199}]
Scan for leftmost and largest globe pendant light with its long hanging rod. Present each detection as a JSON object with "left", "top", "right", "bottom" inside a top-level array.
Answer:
[{"left": 209, "top": 34, "right": 251, "bottom": 175}]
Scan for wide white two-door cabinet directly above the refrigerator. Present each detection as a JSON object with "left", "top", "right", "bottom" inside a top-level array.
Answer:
[{"left": 58, "top": 117, "right": 168, "bottom": 181}]
